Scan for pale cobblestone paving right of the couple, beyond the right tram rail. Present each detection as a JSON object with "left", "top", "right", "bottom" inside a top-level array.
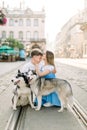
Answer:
[{"left": 56, "top": 59, "right": 87, "bottom": 111}]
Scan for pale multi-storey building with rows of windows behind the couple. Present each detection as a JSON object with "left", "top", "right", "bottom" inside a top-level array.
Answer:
[{"left": 0, "top": 7, "right": 46, "bottom": 52}]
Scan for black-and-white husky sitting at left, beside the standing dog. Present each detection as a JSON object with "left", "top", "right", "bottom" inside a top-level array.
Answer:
[{"left": 11, "top": 70, "right": 35, "bottom": 110}]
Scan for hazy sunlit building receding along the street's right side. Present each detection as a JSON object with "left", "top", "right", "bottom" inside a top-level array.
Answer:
[{"left": 55, "top": 0, "right": 87, "bottom": 58}]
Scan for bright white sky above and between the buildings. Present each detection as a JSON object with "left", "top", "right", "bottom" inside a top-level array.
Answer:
[{"left": 0, "top": 0, "right": 84, "bottom": 42}]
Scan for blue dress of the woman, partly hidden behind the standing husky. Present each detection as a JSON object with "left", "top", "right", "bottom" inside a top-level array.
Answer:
[{"left": 35, "top": 73, "right": 61, "bottom": 106}]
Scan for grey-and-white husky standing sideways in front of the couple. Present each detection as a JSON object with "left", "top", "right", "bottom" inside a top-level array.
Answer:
[{"left": 28, "top": 71, "right": 73, "bottom": 112}]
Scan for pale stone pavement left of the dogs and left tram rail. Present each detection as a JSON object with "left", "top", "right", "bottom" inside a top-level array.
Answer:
[{"left": 0, "top": 62, "right": 24, "bottom": 130}]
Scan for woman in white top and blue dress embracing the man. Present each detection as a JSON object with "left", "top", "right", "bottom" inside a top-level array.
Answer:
[{"left": 35, "top": 51, "right": 61, "bottom": 107}]
